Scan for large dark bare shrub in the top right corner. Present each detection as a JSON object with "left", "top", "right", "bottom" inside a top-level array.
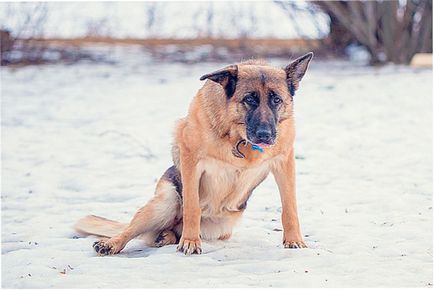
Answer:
[{"left": 311, "top": 0, "right": 432, "bottom": 63}]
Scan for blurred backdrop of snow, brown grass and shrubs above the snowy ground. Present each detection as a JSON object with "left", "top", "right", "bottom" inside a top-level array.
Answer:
[{"left": 0, "top": 0, "right": 432, "bottom": 65}]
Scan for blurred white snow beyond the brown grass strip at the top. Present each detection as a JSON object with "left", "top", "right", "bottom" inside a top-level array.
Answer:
[{"left": 0, "top": 0, "right": 329, "bottom": 38}]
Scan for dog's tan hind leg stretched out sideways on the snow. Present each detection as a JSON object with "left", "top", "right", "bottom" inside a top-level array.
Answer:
[{"left": 93, "top": 174, "right": 182, "bottom": 255}]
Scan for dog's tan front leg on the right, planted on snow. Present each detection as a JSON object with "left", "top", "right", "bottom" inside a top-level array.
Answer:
[{"left": 272, "top": 149, "right": 306, "bottom": 248}]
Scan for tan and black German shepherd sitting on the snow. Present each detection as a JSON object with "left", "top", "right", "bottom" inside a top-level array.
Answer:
[{"left": 75, "top": 53, "right": 313, "bottom": 255}]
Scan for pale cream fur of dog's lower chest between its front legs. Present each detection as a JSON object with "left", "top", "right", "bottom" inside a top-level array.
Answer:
[{"left": 199, "top": 159, "right": 270, "bottom": 217}]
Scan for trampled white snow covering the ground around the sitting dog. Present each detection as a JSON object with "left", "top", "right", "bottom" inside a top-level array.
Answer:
[{"left": 1, "top": 51, "right": 433, "bottom": 288}]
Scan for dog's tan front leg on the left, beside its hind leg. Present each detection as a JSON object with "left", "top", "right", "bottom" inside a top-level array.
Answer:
[{"left": 178, "top": 148, "right": 202, "bottom": 255}]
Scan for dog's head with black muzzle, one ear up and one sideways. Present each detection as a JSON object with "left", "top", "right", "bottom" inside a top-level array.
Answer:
[{"left": 200, "top": 53, "right": 313, "bottom": 147}]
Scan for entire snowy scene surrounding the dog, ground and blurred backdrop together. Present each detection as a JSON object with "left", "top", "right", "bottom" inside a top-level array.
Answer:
[{"left": 0, "top": 0, "right": 433, "bottom": 288}]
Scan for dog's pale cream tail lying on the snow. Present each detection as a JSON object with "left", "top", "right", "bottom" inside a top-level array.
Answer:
[{"left": 74, "top": 215, "right": 127, "bottom": 238}]
